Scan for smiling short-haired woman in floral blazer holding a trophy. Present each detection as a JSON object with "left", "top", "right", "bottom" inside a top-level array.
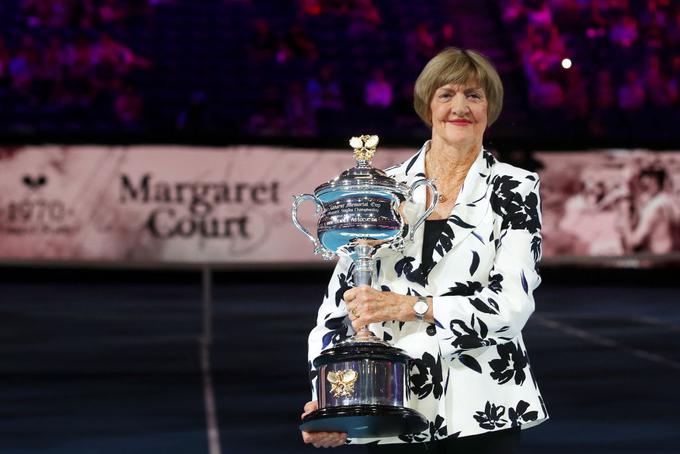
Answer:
[{"left": 302, "top": 48, "right": 548, "bottom": 454}]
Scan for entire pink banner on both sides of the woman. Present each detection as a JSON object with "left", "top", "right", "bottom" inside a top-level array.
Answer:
[{"left": 0, "top": 146, "right": 680, "bottom": 264}]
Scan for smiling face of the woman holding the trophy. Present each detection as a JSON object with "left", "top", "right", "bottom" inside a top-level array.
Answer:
[{"left": 430, "top": 83, "right": 487, "bottom": 151}]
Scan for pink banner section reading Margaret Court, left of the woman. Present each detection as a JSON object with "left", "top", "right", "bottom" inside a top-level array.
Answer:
[{"left": 0, "top": 146, "right": 415, "bottom": 263}]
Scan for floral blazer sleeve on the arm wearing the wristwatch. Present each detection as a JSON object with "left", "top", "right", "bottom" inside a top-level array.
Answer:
[{"left": 433, "top": 173, "right": 541, "bottom": 362}]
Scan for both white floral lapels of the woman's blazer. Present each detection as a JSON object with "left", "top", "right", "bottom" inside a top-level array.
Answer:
[{"left": 395, "top": 141, "right": 495, "bottom": 286}]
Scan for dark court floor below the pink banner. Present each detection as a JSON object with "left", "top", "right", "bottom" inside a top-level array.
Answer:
[{"left": 0, "top": 273, "right": 680, "bottom": 454}]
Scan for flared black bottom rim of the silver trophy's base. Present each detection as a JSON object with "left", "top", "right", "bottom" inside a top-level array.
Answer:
[{"left": 300, "top": 405, "right": 428, "bottom": 438}]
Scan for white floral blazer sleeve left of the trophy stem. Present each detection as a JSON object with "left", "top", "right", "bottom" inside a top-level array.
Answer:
[{"left": 307, "top": 258, "right": 354, "bottom": 400}]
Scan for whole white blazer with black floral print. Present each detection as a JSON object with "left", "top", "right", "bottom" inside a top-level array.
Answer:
[{"left": 308, "top": 141, "right": 548, "bottom": 444}]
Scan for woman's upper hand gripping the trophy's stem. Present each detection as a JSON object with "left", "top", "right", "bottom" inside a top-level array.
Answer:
[{"left": 343, "top": 285, "right": 418, "bottom": 332}]
